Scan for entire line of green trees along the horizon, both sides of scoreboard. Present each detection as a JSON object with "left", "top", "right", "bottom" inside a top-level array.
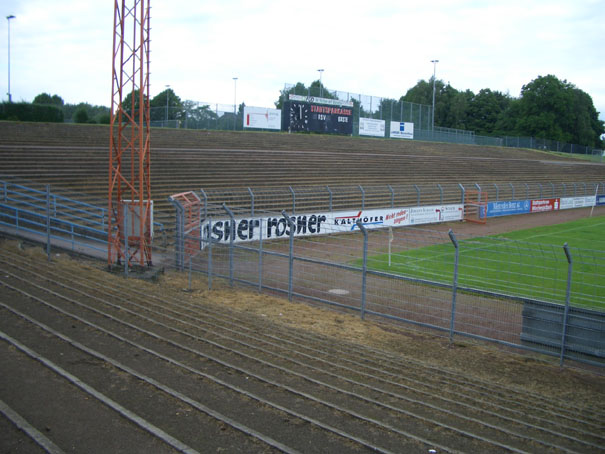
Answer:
[{"left": 0, "top": 75, "right": 605, "bottom": 148}]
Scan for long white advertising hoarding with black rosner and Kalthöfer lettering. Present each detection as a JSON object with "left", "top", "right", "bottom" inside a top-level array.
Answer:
[{"left": 201, "top": 204, "right": 464, "bottom": 244}]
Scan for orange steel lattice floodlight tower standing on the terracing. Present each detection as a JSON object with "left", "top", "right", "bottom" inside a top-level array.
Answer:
[{"left": 107, "top": 0, "right": 153, "bottom": 267}]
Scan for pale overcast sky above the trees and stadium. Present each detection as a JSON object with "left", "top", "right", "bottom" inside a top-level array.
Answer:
[{"left": 0, "top": 0, "right": 605, "bottom": 119}]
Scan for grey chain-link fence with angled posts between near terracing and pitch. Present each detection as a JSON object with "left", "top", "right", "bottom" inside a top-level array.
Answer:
[{"left": 172, "top": 205, "right": 605, "bottom": 366}]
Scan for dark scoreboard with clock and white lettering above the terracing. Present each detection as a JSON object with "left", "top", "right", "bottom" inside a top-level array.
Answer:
[{"left": 282, "top": 98, "right": 353, "bottom": 135}]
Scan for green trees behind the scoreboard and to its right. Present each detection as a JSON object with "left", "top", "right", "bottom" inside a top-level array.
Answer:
[{"left": 275, "top": 75, "right": 605, "bottom": 148}]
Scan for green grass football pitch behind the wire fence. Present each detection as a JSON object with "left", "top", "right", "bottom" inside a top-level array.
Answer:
[{"left": 368, "top": 216, "right": 605, "bottom": 311}]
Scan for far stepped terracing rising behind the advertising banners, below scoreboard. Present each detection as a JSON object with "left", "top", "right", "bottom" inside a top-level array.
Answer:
[{"left": 0, "top": 122, "right": 605, "bottom": 217}]
